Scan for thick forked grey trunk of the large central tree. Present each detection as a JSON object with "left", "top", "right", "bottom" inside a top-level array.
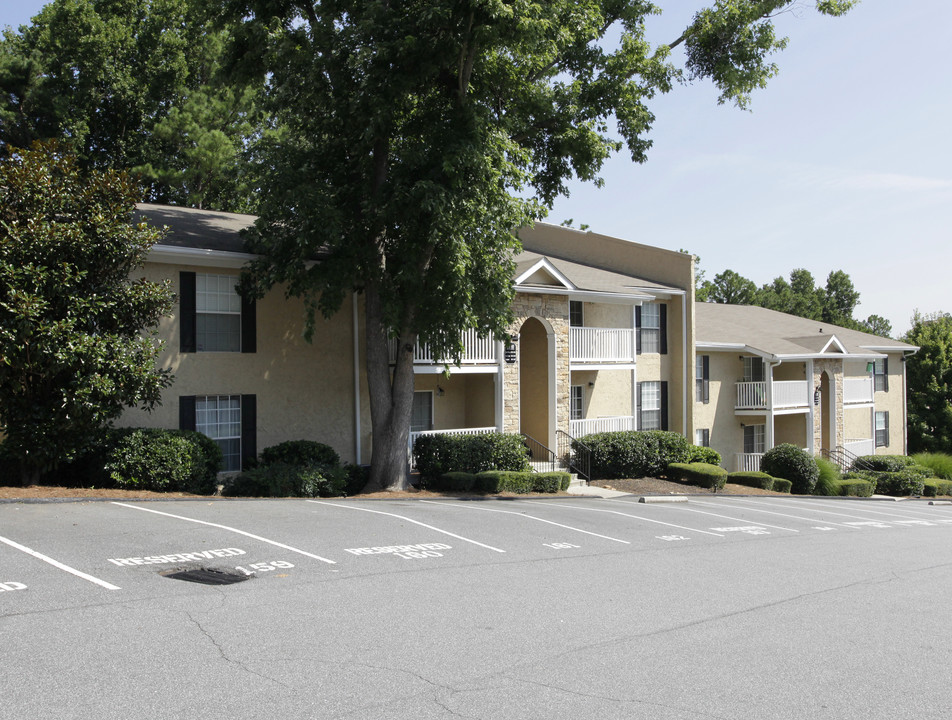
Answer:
[{"left": 365, "top": 286, "right": 416, "bottom": 490}]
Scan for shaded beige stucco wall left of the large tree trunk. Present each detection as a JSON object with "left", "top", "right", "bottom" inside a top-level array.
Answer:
[{"left": 117, "top": 263, "right": 362, "bottom": 462}]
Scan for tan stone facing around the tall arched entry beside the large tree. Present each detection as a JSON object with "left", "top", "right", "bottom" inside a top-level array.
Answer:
[{"left": 502, "top": 293, "right": 571, "bottom": 438}]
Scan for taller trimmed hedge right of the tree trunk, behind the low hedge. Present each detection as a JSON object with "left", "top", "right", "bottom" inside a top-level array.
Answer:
[{"left": 413, "top": 433, "right": 531, "bottom": 480}]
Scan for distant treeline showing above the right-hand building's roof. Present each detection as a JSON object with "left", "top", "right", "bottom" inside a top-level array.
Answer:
[{"left": 696, "top": 268, "right": 892, "bottom": 337}]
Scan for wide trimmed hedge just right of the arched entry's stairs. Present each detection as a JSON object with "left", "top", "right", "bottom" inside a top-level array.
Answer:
[{"left": 581, "top": 430, "right": 690, "bottom": 479}]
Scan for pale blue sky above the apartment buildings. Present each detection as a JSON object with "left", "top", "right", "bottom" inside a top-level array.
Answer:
[{"left": 0, "top": 0, "right": 952, "bottom": 334}]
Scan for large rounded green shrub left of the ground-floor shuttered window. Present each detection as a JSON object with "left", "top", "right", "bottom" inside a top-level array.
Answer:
[{"left": 104, "top": 429, "right": 194, "bottom": 492}]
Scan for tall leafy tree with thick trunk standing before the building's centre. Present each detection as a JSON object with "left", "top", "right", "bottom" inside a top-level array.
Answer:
[{"left": 229, "top": 0, "right": 853, "bottom": 488}]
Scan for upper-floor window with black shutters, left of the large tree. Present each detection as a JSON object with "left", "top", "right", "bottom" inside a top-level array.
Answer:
[{"left": 179, "top": 272, "right": 257, "bottom": 353}]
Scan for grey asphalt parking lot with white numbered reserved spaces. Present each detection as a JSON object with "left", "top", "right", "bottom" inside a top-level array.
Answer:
[{"left": 0, "top": 495, "right": 952, "bottom": 719}]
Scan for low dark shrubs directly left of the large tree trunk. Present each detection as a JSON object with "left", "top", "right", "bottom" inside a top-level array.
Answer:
[{"left": 225, "top": 462, "right": 347, "bottom": 497}]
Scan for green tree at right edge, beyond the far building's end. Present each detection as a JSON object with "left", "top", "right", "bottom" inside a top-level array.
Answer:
[{"left": 903, "top": 311, "right": 952, "bottom": 453}]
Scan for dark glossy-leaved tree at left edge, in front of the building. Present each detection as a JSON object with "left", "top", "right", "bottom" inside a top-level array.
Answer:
[{"left": 0, "top": 143, "right": 172, "bottom": 482}]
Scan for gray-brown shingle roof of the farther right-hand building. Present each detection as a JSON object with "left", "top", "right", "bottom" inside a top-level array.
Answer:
[{"left": 694, "top": 302, "right": 917, "bottom": 356}]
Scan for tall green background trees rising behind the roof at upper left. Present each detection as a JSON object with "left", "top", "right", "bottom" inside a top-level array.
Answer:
[{"left": 0, "top": 0, "right": 257, "bottom": 211}]
